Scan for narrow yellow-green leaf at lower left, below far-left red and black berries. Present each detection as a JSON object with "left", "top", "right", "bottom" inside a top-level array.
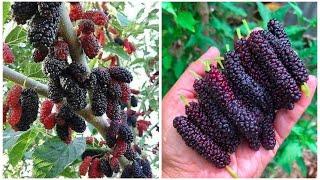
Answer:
[{"left": 8, "top": 129, "right": 38, "bottom": 167}]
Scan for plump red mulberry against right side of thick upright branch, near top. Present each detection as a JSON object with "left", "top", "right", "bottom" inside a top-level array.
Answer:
[{"left": 80, "top": 34, "right": 100, "bottom": 59}]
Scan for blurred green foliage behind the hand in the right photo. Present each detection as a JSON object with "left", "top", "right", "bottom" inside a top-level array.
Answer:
[{"left": 162, "top": 2, "right": 317, "bottom": 177}]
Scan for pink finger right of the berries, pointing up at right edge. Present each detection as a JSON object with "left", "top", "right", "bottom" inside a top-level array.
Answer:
[{"left": 275, "top": 76, "right": 317, "bottom": 142}]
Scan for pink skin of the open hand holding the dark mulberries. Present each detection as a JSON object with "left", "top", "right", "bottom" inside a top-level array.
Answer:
[{"left": 162, "top": 48, "right": 317, "bottom": 178}]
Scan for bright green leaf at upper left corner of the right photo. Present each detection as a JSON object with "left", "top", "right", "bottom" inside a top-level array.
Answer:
[{"left": 175, "top": 12, "right": 197, "bottom": 32}]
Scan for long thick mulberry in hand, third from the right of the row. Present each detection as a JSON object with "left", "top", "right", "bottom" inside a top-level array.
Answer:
[{"left": 248, "top": 31, "right": 301, "bottom": 109}]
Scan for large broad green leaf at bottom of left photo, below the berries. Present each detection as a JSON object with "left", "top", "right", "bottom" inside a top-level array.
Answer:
[{"left": 33, "top": 137, "right": 86, "bottom": 178}]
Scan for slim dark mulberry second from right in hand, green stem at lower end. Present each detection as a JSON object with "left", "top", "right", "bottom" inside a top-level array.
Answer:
[{"left": 261, "top": 31, "right": 309, "bottom": 86}]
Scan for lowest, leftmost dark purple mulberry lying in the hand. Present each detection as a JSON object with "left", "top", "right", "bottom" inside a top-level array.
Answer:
[{"left": 173, "top": 116, "right": 230, "bottom": 168}]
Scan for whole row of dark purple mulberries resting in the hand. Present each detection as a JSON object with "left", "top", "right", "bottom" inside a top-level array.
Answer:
[{"left": 173, "top": 19, "right": 308, "bottom": 168}]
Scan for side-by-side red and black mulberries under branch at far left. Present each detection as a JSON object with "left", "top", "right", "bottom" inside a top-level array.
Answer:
[{"left": 3, "top": 85, "right": 39, "bottom": 131}]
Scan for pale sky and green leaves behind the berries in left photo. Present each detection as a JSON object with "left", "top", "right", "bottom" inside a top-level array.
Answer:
[{"left": 3, "top": 2, "right": 160, "bottom": 178}]
